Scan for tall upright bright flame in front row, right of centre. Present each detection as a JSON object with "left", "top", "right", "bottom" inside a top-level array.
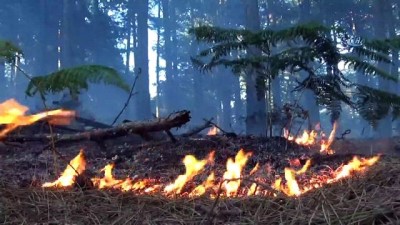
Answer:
[{"left": 223, "top": 149, "right": 252, "bottom": 197}]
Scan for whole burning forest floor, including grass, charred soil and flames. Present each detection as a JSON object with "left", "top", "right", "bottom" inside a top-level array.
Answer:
[{"left": 0, "top": 100, "right": 400, "bottom": 224}]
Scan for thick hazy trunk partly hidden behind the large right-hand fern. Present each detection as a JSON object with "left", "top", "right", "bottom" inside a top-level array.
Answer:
[{"left": 245, "top": 0, "right": 267, "bottom": 136}]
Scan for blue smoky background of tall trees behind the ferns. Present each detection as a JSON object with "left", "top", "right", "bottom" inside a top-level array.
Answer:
[{"left": 0, "top": 0, "right": 400, "bottom": 138}]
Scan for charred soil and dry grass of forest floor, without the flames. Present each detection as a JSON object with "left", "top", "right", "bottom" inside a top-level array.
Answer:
[{"left": 0, "top": 136, "right": 400, "bottom": 224}]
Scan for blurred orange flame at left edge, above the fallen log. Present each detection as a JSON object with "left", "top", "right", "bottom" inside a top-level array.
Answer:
[{"left": 0, "top": 99, "right": 75, "bottom": 137}]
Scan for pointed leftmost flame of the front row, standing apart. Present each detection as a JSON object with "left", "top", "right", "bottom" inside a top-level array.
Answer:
[{"left": 42, "top": 150, "right": 86, "bottom": 187}]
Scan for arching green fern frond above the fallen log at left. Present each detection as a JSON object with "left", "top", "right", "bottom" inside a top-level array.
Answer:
[{"left": 25, "top": 65, "right": 129, "bottom": 96}]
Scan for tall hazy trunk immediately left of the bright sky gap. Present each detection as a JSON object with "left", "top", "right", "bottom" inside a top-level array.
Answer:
[{"left": 135, "top": 0, "right": 152, "bottom": 120}]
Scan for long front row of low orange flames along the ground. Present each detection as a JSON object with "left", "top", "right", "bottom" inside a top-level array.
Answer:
[{"left": 42, "top": 150, "right": 379, "bottom": 197}]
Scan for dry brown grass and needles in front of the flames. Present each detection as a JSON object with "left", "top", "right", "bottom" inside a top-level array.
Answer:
[{"left": 0, "top": 159, "right": 400, "bottom": 224}]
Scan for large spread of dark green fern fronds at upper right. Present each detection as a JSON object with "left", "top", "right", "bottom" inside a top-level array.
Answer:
[{"left": 190, "top": 23, "right": 400, "bottom": 126}]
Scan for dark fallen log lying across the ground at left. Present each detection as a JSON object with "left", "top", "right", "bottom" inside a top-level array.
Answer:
[{"left": 3, "top": 110, "right": 190, "bottom": 143}]
